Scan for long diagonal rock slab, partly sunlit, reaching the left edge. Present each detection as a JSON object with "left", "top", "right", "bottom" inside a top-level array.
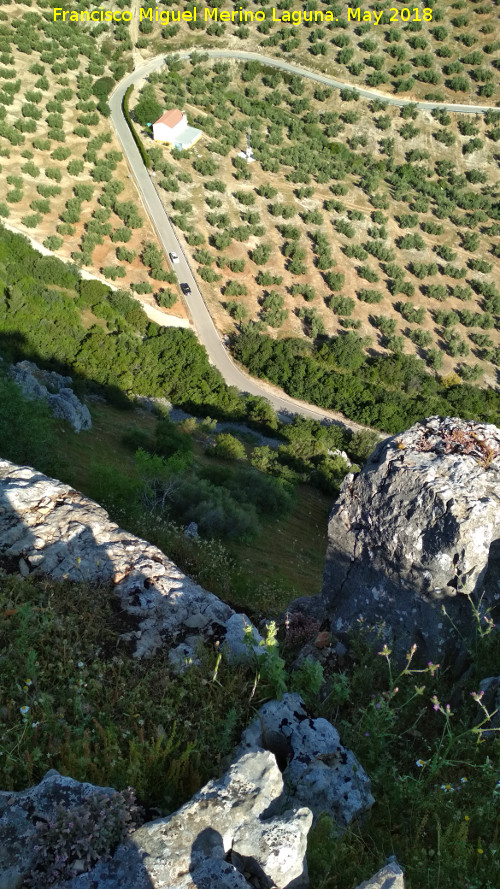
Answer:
[{"left": 0, "top": 460, "right": 260, "bottom": 669}]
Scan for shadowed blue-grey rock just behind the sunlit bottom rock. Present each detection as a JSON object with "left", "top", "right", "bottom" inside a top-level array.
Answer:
[{"left": 240, "top": 694, "right": 374, "bottom": 830}]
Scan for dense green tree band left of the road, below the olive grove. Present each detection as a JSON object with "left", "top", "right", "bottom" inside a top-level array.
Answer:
[{"left": 0, "top": 229, "right": 234, "bottom": 415}]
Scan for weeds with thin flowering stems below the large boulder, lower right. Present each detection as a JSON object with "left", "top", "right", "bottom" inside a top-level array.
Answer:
[{"left": 308, "top": 632, "right": 500, "bottom": 889}]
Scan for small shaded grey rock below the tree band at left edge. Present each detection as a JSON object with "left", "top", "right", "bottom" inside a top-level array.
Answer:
[{"left": 10, "top": 361, "right": 92, "bottom": 432}]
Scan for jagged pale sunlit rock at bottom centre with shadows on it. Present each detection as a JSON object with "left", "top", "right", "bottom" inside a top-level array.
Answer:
[{"left": 47, "top": 751, "right": 312, "bottom": 889}]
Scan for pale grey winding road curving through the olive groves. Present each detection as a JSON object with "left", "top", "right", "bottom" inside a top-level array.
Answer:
[{"left": 109, "top": 47, "right": 492, "bottom": 431}]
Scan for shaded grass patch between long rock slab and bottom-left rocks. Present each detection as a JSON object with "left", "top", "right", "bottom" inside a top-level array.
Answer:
[{"left": 0, "top": 577, "right": 254, "bottom": 811}]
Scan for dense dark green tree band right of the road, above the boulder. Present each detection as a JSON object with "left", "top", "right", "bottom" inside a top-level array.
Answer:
[{"left": 233, "top": 325, "right": 499, "bottom": 434}]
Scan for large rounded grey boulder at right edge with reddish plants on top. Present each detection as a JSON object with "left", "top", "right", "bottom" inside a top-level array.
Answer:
[{"left": 323, "top": 417, "right": 500, "bottom": 659}]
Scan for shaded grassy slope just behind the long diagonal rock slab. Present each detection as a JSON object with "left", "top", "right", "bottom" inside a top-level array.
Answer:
[{"left": 46, "top": 403, "right": 332, "bottom": 617}]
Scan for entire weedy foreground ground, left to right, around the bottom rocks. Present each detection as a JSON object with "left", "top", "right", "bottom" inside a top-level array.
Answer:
[{"left": 0, "top": 555, "right": 500, "bottom": 889}]
